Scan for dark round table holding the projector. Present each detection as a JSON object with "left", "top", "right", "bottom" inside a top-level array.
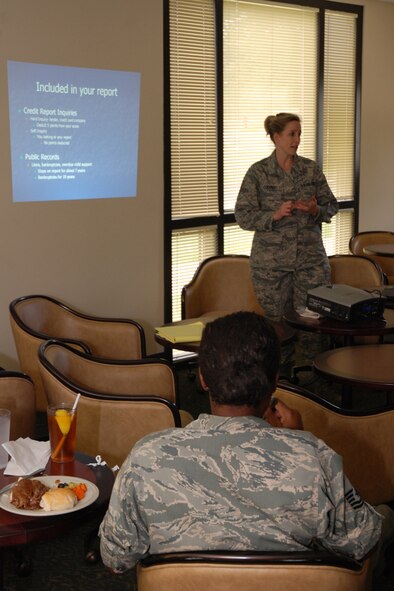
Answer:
[{"left": 284, "top": 309, "right": 394, "bottom": 345}]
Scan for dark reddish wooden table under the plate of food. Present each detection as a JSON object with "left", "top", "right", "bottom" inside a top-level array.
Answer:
[{"left": 0, "top": 454, "right": 114, "bottom": 589}]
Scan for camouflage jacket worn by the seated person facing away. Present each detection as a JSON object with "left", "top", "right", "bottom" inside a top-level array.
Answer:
[{"left": 100, "top": 414, "right": 381, "bottom": 572}]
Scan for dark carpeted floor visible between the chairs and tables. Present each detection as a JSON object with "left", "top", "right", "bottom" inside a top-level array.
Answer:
[{"left": 3, "top": 364, "right": 394, "bottom": 591}]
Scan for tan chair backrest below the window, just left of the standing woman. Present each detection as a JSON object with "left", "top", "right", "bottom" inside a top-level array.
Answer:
[{"left": 182, "top": 255, "right": 264, "bottom": 318}]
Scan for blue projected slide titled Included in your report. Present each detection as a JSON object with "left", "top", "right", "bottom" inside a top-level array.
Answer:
[{"left": 8, "top": 61, "right": 141, "bottom": 202}]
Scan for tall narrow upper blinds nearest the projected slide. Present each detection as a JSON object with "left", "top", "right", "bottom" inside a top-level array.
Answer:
[{"left": 170, "top": 0, "right": 218, "bottom": 219}]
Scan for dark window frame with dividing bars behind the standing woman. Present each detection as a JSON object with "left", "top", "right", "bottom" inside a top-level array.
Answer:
[{"left": 163, "top": 0, "right": 364, "bottom": 322}]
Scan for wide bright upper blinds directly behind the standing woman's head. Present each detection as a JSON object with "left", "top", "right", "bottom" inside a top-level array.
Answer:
[{"left": 223, "top": 0, "right": 317, "bottom": 211}]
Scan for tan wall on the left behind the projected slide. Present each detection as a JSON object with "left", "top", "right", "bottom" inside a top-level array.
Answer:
[{"left": 0, "top": 0, "right": 163, "bottom": 369}]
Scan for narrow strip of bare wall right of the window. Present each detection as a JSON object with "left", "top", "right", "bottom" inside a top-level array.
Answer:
[{"left": 359, "top": 0, "right": 394, "bottom": 231}]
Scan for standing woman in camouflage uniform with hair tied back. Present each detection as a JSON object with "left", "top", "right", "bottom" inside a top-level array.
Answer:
[{"left": 235, "top": 113, "right": 338, "bottom": 364}]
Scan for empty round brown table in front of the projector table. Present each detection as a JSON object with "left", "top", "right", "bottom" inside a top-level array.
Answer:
[{"left": 313, "top": 343, "right": 394, "bottom": 407}]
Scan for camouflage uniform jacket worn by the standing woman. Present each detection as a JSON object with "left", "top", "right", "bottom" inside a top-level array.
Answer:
[{"left": 235, "top": 151, "right": 338, "bottom": 270}]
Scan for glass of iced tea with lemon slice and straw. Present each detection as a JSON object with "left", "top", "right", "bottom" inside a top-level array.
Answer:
[{"left": 48, "top": 402, "right": 77, "bottom": 463}]
